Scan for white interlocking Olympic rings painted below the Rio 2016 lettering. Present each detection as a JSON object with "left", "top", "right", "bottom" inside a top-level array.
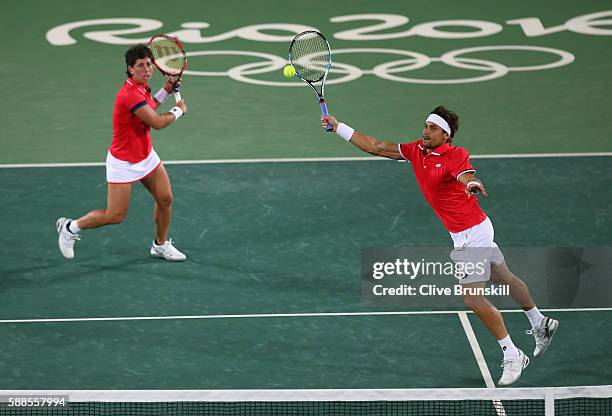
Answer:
[{"left": 185, "top": 45, "right": 575, "bottom": 87}]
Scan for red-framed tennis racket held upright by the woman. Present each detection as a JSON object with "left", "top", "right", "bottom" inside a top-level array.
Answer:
[{"left": 149, "top": 34, "right": 187, "bottom": 102}]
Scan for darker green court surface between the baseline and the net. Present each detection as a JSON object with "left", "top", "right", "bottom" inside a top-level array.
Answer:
[{"left": 0, "top": 157, "right": 612, "bottom": 389}]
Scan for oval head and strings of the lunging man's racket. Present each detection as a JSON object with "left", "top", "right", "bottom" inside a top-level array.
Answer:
[{"left": 291, "top": 32, "right": 330, "bottom": 82}]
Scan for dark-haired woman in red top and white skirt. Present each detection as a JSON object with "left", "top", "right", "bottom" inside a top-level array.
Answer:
[{"left": 56, "top": 44, "right": 187, "bottom": 261}]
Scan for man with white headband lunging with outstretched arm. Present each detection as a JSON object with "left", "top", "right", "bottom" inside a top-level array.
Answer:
[{"left": 321, "top": 106, "right": 559, "bottom": 386}]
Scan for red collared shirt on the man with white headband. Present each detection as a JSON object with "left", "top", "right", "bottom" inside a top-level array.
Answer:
[{"left": 399, "top": 140, "right": 487, "bottom": 233}]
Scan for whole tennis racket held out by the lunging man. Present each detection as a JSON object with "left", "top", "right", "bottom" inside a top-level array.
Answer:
[{"left": 289, "top": 30, "right": 333, "bottom": 131}]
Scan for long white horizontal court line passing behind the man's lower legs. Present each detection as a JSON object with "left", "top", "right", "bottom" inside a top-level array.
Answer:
[{"left": 0, "top": 308, "right": 612, "bottom": 324}]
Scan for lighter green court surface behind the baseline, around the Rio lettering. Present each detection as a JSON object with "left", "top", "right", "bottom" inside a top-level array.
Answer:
[{"left": 0, "top": 0, "right": 612, "bottom": 163}]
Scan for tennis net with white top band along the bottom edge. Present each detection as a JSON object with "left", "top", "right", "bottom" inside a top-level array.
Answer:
[{"left": 0, "top": 385, "right": 612, "bottom": 416}]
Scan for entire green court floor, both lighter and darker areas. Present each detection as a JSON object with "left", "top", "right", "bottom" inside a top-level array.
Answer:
[{"left": 0, "top": 0, "right": 612, "bottom": 410}]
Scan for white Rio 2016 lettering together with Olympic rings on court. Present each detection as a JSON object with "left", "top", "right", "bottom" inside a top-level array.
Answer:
[{"left": 46, "top": 10, "right": 612, "bottom": 87}]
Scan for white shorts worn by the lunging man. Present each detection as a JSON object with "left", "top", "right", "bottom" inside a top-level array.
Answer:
[{"left": 450, "top": 217, "right": 504, "bottom": 284}]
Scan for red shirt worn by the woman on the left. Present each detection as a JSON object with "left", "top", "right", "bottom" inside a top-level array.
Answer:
[{"left": 109, "top": 78, "right": 157, "bottom": 163}]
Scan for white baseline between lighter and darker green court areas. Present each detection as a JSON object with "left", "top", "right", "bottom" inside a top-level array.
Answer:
[{"left": 0, "top": 152, "right": 612, "bottom": 169}]
